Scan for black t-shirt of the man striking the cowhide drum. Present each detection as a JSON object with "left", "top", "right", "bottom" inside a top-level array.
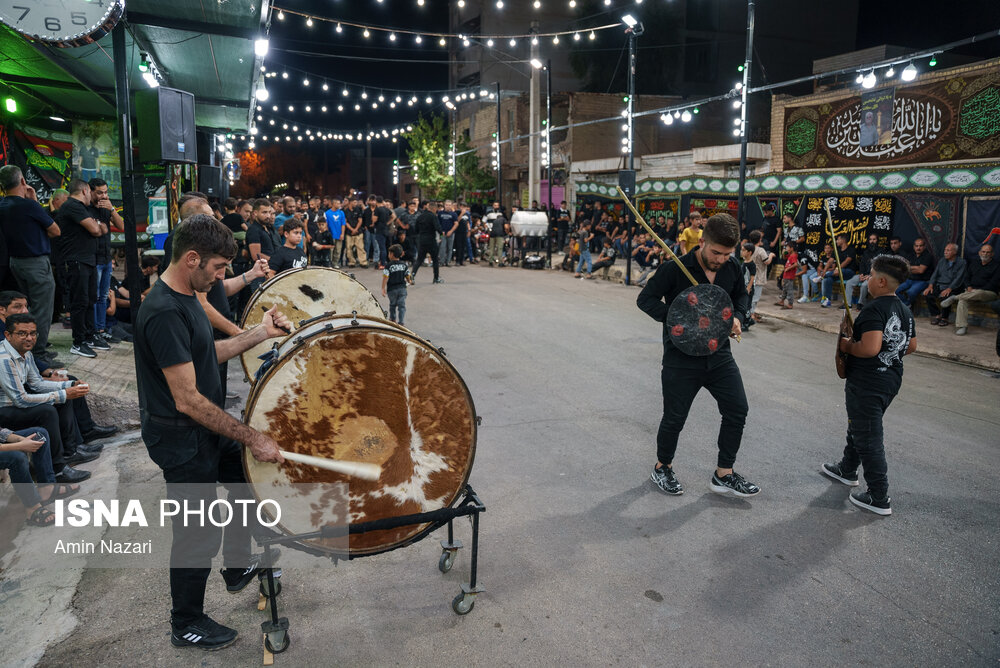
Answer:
[{"left": 134, "top": 281, "right": 223, "bottom": 418}]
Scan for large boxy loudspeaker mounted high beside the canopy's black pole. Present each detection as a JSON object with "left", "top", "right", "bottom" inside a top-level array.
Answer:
[{"left": 135, "top": 86, "right": 198, "bottom": 164}]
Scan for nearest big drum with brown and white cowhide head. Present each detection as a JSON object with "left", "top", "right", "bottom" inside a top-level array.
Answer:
[{"left": 243, "top": 316, "right": 476, "bottom": 556}]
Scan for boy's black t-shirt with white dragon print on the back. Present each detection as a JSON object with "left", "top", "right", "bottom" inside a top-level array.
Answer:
[{"left": 847, "top": 295, "right": 917, "bottom": 394}]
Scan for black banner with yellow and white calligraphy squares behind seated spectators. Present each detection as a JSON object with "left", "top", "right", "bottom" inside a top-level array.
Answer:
[{"left": 802, "top": 196, "right": 895, "bottom": 254}]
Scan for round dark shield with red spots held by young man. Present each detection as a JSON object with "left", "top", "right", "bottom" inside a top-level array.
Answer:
[{"left": 667, "top": 283, "right": 733, "bottom": 357}]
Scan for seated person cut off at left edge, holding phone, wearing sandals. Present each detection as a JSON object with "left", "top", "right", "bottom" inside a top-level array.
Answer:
[{"left": 0, "top": 427, "right": 80, "bottom": 527}]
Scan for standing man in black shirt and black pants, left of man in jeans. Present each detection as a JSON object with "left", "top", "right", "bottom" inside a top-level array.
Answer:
[{"left": 56, "top": 179, "right": 108, "bottom": 357}]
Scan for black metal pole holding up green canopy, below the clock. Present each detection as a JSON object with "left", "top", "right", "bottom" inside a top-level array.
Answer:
[{"left": 111, "top": 21, "right": 143, "bottom": 312}]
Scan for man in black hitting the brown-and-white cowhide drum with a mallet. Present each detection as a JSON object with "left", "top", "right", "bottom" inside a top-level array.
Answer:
[{"left": 135, "top": 214, "right": 288, "bottom": 650}]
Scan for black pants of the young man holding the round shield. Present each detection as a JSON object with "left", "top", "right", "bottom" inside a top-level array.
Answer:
[{"left": 656, "top": 355, "right": 749, "bottom": 469}]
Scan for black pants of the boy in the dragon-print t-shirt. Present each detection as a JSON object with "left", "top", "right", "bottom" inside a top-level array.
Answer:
[{"left": 841, "top": 381, "right": 900, "bottom": 499}]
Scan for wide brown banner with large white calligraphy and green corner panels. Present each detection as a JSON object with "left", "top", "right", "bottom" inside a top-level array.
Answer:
[{"left": 784, "top": 68, "right": 1000, "bottom": 169}]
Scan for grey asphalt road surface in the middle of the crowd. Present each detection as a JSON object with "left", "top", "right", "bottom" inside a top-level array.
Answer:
[{"left": 29, "top": 266, "right": 1000, "bottom": 666}]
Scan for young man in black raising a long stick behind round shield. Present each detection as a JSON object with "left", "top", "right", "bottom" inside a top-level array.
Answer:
[{"left": 636, "top": 213, "right": 760, "bottom": 496}]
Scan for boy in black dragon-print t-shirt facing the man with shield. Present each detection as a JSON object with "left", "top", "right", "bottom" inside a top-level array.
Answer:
[{"left": 821, "top": 255, "right": 917, "bottom": 515}]
